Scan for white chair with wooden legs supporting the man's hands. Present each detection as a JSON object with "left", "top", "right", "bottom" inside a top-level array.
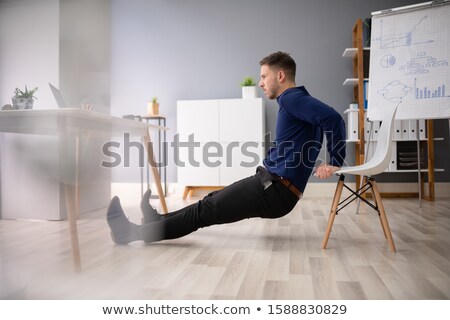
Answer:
[{"left": 322, "top": 104, "right": 399, "bottom": 252}]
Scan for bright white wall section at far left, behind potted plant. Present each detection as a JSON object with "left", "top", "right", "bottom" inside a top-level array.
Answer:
[{"left": 0, "top": 0, "right": 59, "bottom": 109}]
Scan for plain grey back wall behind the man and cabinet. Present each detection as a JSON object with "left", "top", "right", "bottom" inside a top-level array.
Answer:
[{"left": 111, "top": 0, "right": 442, "bottom": 181}]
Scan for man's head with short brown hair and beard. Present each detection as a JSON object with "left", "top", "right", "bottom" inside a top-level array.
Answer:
[{"left": 259, "top": 51, "right": 296, "bottom": 99}]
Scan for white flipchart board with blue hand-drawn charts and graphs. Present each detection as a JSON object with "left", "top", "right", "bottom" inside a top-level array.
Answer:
[{"left": 367, "top": 1, "right": 450, "bottom": 120}]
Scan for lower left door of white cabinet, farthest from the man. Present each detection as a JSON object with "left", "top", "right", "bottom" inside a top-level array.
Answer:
[{"left": 175, "top": 144, "right": 220, "bottom": 186}]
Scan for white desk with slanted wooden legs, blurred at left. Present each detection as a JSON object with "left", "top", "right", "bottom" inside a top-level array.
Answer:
[{"left": 0, "top": 109, "right": 167, "bottom": 271}]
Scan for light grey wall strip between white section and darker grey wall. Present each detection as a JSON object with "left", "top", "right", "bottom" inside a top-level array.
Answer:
[{"left": 59, "top": 0, "right": 111, "bottom": 113}]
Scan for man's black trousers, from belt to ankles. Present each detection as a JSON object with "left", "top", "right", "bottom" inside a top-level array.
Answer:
[{"left": 141, "top": 167, "right": 299, "bottom": 243}]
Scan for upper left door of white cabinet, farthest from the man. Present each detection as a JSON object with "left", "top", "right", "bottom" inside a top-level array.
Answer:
[{"left": 177, "top": 100, "right": 219, "bottom": 143}]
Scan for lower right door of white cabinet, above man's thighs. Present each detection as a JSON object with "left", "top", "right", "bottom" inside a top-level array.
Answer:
[{"left": 220, "top": 142, "right": 264, "bottom": 186}]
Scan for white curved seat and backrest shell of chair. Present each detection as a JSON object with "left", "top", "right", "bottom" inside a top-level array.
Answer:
[{"left": 337, "top": 103, "right": 400, "bottom": 176}]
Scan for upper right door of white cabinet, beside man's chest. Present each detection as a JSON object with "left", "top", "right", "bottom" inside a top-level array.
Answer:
[{"left": 219, "top": 98, "right": 264, "bottom": 142}]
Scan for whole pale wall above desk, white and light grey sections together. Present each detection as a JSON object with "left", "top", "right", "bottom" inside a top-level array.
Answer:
[{"left": 0, "top": 0, "right": 111, "bottom": 113}]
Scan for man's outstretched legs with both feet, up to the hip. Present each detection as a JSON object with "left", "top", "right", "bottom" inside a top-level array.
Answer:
[{"left": 107, "top": 175, "right": 262, "bottom": 244}]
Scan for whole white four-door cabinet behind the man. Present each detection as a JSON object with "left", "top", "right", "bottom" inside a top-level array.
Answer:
[{"left": 176, "top": 98, "right": 265, "bottom": 187}]
